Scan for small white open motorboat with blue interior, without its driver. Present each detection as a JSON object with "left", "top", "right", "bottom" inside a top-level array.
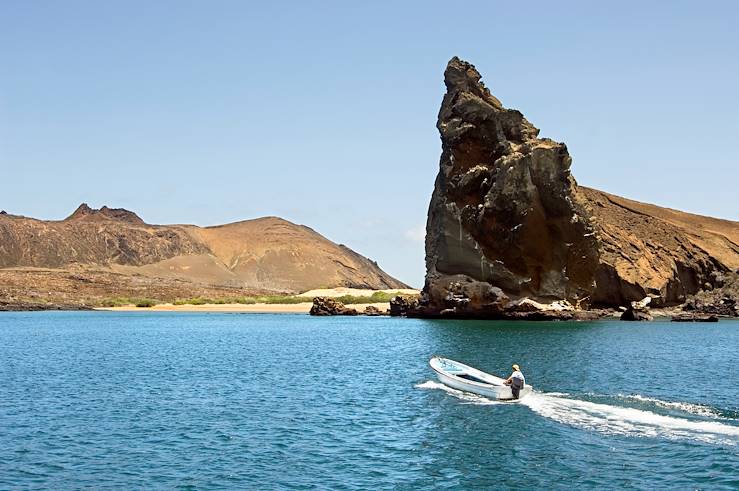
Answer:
[{"left": 429, "top": 356, "right": 532, "bottom": 401}]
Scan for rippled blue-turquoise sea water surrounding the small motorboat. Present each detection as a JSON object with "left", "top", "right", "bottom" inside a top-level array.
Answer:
[{"left": 0, "top": 312, "right": 739, "bottom": 489}]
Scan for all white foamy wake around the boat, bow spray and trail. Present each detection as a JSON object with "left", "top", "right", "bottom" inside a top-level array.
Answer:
[{"left": 417, "top": 381, "right": 739, "bottom": 446}]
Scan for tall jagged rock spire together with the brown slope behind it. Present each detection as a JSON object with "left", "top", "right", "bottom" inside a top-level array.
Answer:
[{"left": 419, "top": 57, "right": 739, "bottom": 317}]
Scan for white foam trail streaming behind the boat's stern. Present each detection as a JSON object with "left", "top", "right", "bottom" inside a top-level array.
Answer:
[{"left": 521, "top": 392, "right": 739, "bottom": 445}]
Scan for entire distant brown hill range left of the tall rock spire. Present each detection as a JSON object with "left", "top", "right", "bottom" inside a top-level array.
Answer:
[{"left": 0, "top": 204, "right": 406, "bottom": 304}]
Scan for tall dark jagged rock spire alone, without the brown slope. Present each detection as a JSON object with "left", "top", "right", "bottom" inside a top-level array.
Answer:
[{"left": 422, "top": 57, "right": 598, "bottom": 314}]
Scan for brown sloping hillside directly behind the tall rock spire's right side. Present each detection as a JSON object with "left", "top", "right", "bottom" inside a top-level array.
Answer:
[{"left": 578, "top": 186, "right": 739, "bottom": 305}]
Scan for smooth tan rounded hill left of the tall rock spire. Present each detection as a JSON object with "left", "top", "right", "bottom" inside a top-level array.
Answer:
[{"left": 124, "top": 217, "right": 406, "bottom": 292}]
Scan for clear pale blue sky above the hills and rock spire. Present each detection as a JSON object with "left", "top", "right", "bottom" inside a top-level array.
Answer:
[{"left": 0, "top": 0, "right": 739, "bottom": 287}]
